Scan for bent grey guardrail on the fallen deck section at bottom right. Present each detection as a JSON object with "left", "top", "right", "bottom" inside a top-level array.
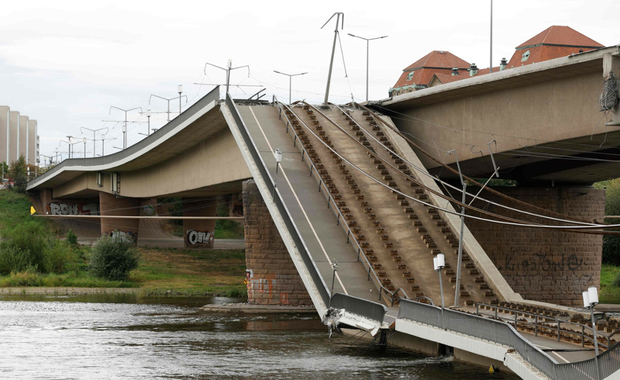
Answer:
[{"left": 398, "top": 300, "right": 620, "bottom": 380}]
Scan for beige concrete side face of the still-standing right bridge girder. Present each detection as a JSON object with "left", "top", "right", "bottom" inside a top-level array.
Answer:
[{"left": 394, "top": 68, "right": 603, "bottom": 169}]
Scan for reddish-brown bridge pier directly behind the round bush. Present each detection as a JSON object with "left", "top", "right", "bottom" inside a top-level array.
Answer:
[{"left": 99, "top": 192, "right": 142, "bottom": 243}]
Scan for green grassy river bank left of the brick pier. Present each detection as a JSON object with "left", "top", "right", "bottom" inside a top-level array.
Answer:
[{"left": 0, "top": 190, "right": 246, "bottom": 297}]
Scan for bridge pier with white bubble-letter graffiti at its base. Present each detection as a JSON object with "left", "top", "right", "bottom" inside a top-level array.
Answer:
[{"left": 183, "top": 197, "right": 217, "bottom": 248}]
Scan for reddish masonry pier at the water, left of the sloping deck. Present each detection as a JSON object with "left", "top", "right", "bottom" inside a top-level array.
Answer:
[{"left": 243, "top": 180, "right": 312, "bottom": 305}]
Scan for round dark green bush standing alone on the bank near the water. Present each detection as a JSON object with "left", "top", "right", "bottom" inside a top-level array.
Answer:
[{"left": 90, "top": 236, "right": 140, "bottom": 281}]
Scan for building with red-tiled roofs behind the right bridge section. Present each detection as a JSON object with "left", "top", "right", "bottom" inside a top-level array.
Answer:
[{"left": 388, "top": 25, "right": 604, "bottom": 97}]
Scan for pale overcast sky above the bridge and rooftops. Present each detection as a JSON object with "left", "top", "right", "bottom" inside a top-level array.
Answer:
[{"left": 0, "top": 0, "right": 620, "bottom": 165}]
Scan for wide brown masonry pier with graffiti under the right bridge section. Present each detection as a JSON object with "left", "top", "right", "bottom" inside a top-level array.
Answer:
[{"left": 467, "top": 187, "right": 605, "bottom": 306}]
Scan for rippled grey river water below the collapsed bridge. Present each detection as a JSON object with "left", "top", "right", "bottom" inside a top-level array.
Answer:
[{"left": 0, "top": 296, "right": 517, "bottom": 380}]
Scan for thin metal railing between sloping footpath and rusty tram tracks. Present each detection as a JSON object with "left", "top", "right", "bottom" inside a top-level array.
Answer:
[{"left": 274, "top": 98, "right": 409, "bottom": 306}]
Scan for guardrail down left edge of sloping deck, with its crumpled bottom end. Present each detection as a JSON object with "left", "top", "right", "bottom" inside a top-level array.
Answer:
[{"left": 226, "top": 94, "right": 387, "bottom": 324}]
